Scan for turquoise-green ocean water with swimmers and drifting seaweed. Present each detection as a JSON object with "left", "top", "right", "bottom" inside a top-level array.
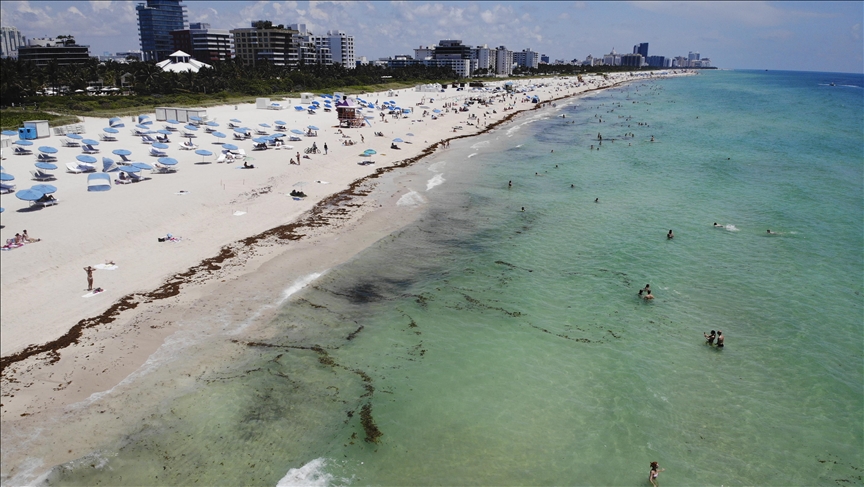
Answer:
[{"left": 42, "top": 71, "right": 864, "bottom": 486}]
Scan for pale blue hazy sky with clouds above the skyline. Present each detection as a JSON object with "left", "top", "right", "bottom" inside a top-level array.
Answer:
[{"left": 0, "top": 0, "right": 864, "bottom": 73}]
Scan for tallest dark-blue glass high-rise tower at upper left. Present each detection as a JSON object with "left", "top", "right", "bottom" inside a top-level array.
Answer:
[{"left": 135, "top": 0, "right": 186, "bottom": 61}]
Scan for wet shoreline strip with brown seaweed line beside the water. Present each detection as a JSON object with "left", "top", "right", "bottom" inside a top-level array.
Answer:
[{"left": 0, "top": 69, "right": 688, "bottom": 479}]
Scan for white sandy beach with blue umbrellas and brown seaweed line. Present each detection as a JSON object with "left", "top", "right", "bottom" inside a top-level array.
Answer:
[{"left": 0, "top": 73, "right": 688, "bottom": 479}]
